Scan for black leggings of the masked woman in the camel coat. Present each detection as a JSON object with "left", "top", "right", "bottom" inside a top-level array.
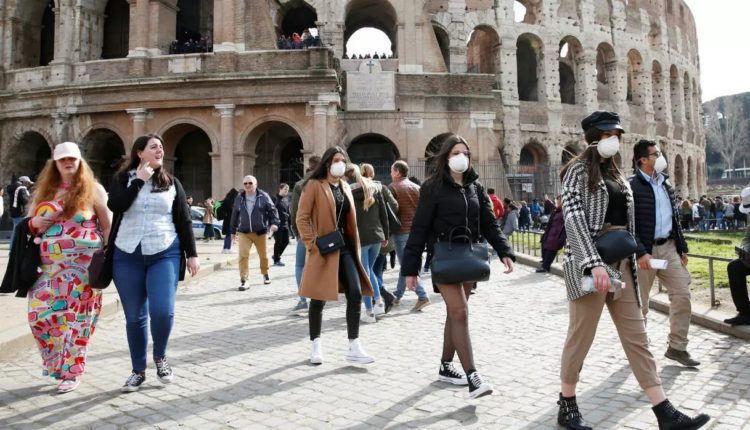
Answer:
[{"left": 309, "top": 251, "right": 362, "bottom": 340}]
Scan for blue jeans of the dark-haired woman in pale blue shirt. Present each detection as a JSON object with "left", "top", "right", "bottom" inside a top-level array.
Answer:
[{"left": 112, "top": 239, "right": 181, "bottom": 372}]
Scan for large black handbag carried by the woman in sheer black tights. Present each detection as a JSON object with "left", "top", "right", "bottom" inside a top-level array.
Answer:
[{"left": 430, "top": 226, "right": 490, "bottom": 284}]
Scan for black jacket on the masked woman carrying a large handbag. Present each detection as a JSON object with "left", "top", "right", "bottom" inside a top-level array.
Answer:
[{"left": 401, "top": 170, "right": 516, "bottom": 276}]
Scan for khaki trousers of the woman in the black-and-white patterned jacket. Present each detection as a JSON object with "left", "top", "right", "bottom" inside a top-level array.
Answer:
[{"left": 560, "top": 260, "right": 661, "bottom": 389}]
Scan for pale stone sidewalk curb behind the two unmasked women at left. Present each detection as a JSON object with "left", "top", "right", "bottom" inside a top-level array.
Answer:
[{"left": 0, "top": 255, "right": 239, "bottom": 362}]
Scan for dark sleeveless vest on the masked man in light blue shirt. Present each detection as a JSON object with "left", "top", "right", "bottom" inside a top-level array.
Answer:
[{"left": 629, "top": 173, "right": 688, "bottom": 257}]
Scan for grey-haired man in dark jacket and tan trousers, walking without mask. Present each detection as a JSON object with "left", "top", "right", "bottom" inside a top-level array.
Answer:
[{"left": 231, "top": 175, "right": 279, "bottom": 291}]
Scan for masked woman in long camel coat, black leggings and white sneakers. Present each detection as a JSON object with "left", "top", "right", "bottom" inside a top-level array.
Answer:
[{"left": 296, "top": 146, "right": 374, "bottom": 364}]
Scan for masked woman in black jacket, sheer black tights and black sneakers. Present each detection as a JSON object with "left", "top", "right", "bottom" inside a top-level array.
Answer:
[{"left": 401, "top": 134, "right": 515, "bottom": 398}]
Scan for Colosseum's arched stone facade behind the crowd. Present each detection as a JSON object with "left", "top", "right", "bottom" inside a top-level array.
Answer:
[{"left": 0, "top": 0, "right": 706, "bottom": 208}]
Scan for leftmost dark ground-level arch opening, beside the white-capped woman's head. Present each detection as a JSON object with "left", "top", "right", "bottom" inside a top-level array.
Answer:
[{"left": 5, "top": 130, "right": 52, "bottom": 180}]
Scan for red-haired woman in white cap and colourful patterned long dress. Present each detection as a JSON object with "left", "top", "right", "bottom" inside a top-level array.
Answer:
[{"left": 28, "top": 142, "right": 112, "bottom": 393}]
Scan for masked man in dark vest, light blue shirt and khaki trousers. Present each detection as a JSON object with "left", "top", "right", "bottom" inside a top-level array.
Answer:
[{"left": 630, "top": 140, "right": 700, "bottom": 367}]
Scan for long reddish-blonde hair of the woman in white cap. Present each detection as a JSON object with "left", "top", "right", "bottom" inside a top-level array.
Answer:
[{"left": 29, "top": 158, "right": 97, "bottom": 218}]
